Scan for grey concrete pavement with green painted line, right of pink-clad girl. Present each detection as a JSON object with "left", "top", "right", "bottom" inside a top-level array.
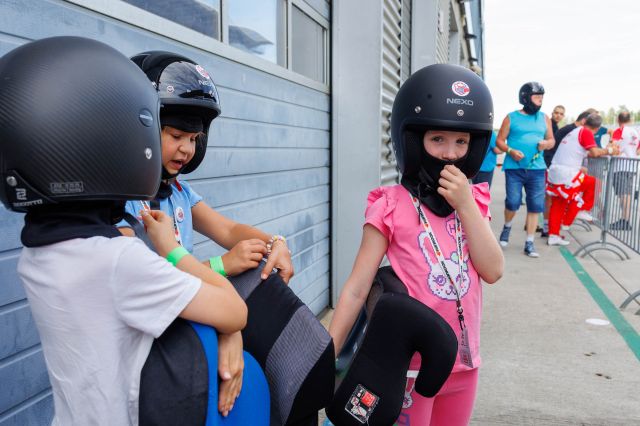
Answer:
[{"left": 471, "top": 170, "right": 640, "bottom": 425}]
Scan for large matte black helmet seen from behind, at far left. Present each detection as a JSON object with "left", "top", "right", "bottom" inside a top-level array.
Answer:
[{"left": 0, "top": 37, "right": 161, "bottom": 211}]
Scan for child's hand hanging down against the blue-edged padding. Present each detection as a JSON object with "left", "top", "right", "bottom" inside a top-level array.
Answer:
[{"left": 218, "top": 331, "right": 244, "bottom": 417}]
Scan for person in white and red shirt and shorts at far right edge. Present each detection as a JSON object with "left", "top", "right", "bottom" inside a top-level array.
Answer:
[{"left": 610, "top": 111, "right": 640, "bottom": 231}]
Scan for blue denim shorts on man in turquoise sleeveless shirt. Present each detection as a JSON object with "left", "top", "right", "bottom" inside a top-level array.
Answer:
[{"left": 504, "top": 169, "right": 546, "bottom": 213}]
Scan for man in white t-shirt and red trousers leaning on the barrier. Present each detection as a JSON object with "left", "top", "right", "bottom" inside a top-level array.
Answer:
[{"left": 547, "top": 114, "right": 617, "bottom": 246}]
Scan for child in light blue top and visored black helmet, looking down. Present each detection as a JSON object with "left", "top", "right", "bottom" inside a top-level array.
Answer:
[{"left": 118, "top": 51, "right": 293, "bottom": 413}]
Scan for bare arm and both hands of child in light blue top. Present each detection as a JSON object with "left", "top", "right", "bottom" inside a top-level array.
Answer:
[{"left": 191, "top": 201, "right": 293, "bottom": 283}]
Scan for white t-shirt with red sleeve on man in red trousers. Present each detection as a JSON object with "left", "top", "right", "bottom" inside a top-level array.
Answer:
[{"left": 547, "top": 126, "right": 598, "bottom": 185}]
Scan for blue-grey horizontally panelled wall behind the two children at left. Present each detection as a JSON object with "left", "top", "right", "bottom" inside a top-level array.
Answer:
[{"left": 0, "top": 0, "right": 330, "bottom": 426}]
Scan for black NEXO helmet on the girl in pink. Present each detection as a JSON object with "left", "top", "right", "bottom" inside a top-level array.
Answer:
[{"left": 391, "top": 64, "right": 493, "bottom": 181}]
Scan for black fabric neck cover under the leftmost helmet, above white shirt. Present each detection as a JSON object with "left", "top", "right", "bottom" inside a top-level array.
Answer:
[{"left": 20, "top": 201, "right": 124, "bottom": 247}]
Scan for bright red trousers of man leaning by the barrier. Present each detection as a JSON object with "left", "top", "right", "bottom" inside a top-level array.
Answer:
[{"left": 547, "top": 174, "right": 596, "bottom": 235}]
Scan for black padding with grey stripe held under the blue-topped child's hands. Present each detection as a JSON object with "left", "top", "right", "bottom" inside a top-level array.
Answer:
[{"left": 229, "top": 262, "right": 335, "bottom": 426}]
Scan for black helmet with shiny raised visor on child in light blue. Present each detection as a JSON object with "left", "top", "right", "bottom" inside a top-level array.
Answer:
[{"left": 131, "top": 50, "right": 220, "bottom": 174}]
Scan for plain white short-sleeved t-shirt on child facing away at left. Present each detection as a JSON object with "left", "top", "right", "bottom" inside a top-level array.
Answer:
[{"left": 18, "top": 237, "right": 201, "bottom": 426}]
